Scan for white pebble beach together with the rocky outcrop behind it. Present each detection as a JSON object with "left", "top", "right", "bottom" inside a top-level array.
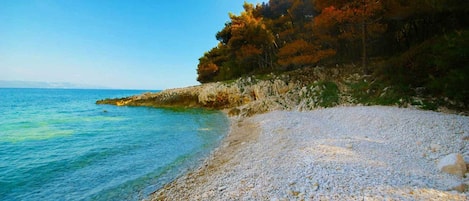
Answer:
[{"left": 97, "top": 67, "right": 469, "bottom": 200}]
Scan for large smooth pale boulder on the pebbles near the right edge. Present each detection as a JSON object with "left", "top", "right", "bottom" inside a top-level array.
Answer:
[{"left": 438, "top": 153, "right": 467, "bottom": 177}]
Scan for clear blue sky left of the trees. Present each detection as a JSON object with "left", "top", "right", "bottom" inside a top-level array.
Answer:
[{"left": 0, "top": 0, "right": 262, "bottom": 90}]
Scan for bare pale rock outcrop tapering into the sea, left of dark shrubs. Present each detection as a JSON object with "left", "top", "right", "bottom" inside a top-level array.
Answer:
[{"left": 97, "top": 67, "right": 361, "bottom": 116}]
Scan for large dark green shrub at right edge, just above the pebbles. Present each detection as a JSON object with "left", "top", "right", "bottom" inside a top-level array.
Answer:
[{"left": 375, "top": 30, "right": 469, "bottom": 108}]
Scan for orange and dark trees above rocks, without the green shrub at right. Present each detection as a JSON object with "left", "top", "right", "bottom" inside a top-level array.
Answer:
[{"left": 197, "top": 0, "right": 469, "bottom": 83}]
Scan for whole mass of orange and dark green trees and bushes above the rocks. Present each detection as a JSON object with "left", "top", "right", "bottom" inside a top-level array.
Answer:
[{"left": 197, "top": 0, "right": 469, "bottom": 110}]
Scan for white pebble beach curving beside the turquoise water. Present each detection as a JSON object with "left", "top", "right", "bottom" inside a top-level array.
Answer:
[{"left": 148, "top": 106, "right": 469, "bottom": 200}]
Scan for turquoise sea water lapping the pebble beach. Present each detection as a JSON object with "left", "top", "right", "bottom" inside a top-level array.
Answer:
[{"left": 0, "top": 89, "right": 228, "bottom": 200}]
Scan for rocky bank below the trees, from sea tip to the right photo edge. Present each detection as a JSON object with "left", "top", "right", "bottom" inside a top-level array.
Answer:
[{"left": 97, "top": 62, "right": 467, "bottom": 116}]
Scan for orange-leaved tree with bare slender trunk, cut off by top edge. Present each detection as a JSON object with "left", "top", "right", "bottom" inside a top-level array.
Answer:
[{"left": 313, "top": 0, "right": 386, "bottom": 73}]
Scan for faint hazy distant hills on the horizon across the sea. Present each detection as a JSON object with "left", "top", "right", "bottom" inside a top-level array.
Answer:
[{"left": 0, "top": 80, "right": 108, "bottom": 89}]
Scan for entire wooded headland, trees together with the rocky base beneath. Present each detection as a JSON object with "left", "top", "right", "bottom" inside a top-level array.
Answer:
[{"left": 98, "top": 0, "right": 469, "bottom": 116}]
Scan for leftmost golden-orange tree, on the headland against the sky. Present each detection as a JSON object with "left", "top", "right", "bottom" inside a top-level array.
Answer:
[{"left": 197, "top": 3, "right": 276, "bottom": 82}]
